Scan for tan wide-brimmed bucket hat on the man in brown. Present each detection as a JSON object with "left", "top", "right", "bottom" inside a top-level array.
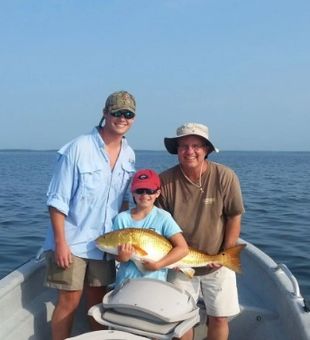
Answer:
[{"left": 164, "top": 123, "right": 219, "bottom": 154}]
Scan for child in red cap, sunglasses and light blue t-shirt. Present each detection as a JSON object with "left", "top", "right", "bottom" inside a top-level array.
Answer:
[{"left": 113, "top": 169, "right": 189, "bottom": 285}]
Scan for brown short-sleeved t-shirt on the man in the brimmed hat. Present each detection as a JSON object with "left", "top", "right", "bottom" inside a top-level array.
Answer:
[{"left": 157, "top": 161, "right": 244, "bottom": 255}]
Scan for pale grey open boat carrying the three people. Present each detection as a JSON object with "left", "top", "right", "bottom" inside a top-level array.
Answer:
[{"left": 0, "top": 239, "right": 310, "bottom": 340}]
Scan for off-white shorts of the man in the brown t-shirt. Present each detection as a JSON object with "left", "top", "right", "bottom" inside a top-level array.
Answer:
[{"left": 167, "top": 267, "right": 240, "bottom": 317}]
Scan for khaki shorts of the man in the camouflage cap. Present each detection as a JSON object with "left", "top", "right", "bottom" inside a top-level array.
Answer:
[{"left": 45, "top": 251, "right": 115, "bottom": 290}]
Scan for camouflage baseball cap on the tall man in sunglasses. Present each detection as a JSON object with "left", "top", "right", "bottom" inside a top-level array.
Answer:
[{"left": 104, "top": 91, "right": 136, "bottom": 113}]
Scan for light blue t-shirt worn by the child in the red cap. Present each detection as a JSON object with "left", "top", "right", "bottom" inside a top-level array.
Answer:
[{"left": 113, "top": 206, "right": 182, "bottom": 285}]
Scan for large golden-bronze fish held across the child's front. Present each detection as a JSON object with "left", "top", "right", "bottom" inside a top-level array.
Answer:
[{"left": 96, "top": 228, "right": 245, "bottom": 276}]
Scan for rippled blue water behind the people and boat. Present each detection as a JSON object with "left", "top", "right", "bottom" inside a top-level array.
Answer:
[{"left": 0, "top": 151, "right": 310, "bottom": 299}]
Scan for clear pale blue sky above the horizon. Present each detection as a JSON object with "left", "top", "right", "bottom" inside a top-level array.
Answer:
[{"left": 0, "top": 0, "right": 310, "bottom": 151}]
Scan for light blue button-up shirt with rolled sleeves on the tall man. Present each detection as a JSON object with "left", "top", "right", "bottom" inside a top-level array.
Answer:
[{"left": 43, "top": 128, "right": 135, "bottom": 259}]
